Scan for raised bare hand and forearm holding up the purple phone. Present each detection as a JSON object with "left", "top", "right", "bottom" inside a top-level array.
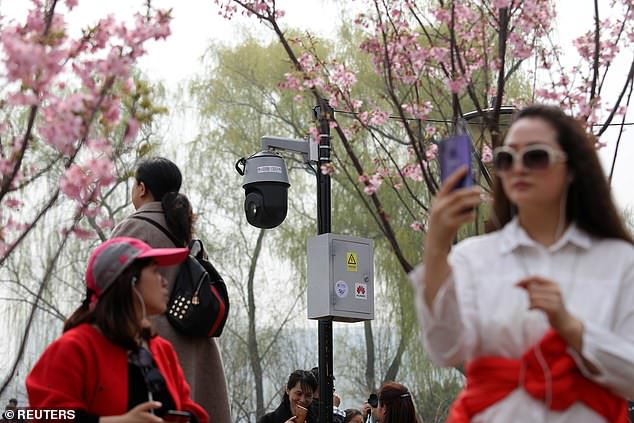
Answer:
[{"left": 421, "top": 166, "right": 482, "bottom": 308}]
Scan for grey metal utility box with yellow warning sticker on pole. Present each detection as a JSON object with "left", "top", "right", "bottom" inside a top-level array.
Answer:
[{"left": 308, "top": 233, "right": 374, "bottom": 322}]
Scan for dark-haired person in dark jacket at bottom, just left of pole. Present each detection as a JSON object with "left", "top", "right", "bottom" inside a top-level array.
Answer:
[{"left": 258, "top": 370, "right": 317, "bottom": 423}]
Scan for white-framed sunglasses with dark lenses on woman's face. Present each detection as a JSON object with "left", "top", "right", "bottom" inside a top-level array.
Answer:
[{"left": 493, "top": 144, "right": 567, "bottom": 172}]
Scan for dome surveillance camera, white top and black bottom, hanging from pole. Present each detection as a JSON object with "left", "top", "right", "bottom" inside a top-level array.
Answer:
[{"left": 236, "top": 150, "right": 290, "bottom": 229}]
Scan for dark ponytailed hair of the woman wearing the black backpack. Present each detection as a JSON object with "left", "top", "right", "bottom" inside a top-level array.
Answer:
[{"left": 136, "top": 157, "right": 194, "bottom": 247}]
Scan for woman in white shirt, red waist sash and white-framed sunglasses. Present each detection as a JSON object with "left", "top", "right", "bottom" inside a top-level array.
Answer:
[{"left": 411, "top": 106, "right": 634, "bottom": 423}]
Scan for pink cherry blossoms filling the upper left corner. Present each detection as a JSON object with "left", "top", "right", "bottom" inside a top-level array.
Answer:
[{"left": 0, "top": 0, "right": 171, "bottom": 255}]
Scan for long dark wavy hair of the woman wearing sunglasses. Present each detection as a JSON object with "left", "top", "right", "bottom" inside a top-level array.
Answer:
[{"left": 488, "top": 105, "right": 634, "bottom": 243}]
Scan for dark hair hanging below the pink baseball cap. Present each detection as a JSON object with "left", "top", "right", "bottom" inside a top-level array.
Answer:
[{"left": 64, "top": 259, "right": 153, "bottom": 351}]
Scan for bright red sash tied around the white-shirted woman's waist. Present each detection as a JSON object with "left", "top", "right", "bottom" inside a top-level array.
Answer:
[{"left": 447, "top": 330, "right": 629, "bottom": 423}]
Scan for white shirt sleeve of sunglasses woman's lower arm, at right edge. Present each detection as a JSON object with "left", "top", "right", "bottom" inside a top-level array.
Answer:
[{"left": 573, "top": 260, "right": 634, "bottom": 398}]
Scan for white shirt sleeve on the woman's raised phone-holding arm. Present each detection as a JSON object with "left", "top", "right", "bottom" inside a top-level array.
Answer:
[{"left": 409, "top": 248, "right": 477, "bottom": 366}]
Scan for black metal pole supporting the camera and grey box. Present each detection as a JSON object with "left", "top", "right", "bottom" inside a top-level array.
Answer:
[{"left": 314, "top": 98, "right": 335, "bottom": 423}]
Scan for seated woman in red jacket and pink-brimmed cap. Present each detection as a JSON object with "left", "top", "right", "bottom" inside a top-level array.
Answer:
[{"left": 26, "top": 237, "right": 208, "bottom": 423}]
